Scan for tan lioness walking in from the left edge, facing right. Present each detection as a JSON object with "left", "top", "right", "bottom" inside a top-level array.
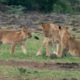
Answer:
[{"left": 0, "top": 26, "right": 31, "bottom": 53}]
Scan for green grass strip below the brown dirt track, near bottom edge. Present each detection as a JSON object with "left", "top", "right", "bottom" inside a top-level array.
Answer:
[{"left": 0, "top": 66, "right": 80, "bottom": 80}]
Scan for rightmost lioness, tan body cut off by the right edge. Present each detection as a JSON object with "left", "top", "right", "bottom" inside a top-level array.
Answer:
[{"left": 57, "top": 26, "right": 80, "bottom": 56}]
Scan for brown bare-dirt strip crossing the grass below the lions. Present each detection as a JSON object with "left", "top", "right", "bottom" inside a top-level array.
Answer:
[{"left": 0, "top": 60, "right": 80, "bottom": 70}]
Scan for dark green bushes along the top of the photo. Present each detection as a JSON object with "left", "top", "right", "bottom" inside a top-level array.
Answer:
[{"left": 0, "top": 0, "right": 80, "bottom": 13}]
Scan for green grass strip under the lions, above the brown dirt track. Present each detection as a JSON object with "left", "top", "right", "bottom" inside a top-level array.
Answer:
[{"left": 0, "top": 34, "right": 80, "bottom": 63}]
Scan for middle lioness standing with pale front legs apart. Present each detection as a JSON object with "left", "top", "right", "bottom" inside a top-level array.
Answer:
[{"left": 37, "top": 23, "right": 60, "bottom": 56}]
